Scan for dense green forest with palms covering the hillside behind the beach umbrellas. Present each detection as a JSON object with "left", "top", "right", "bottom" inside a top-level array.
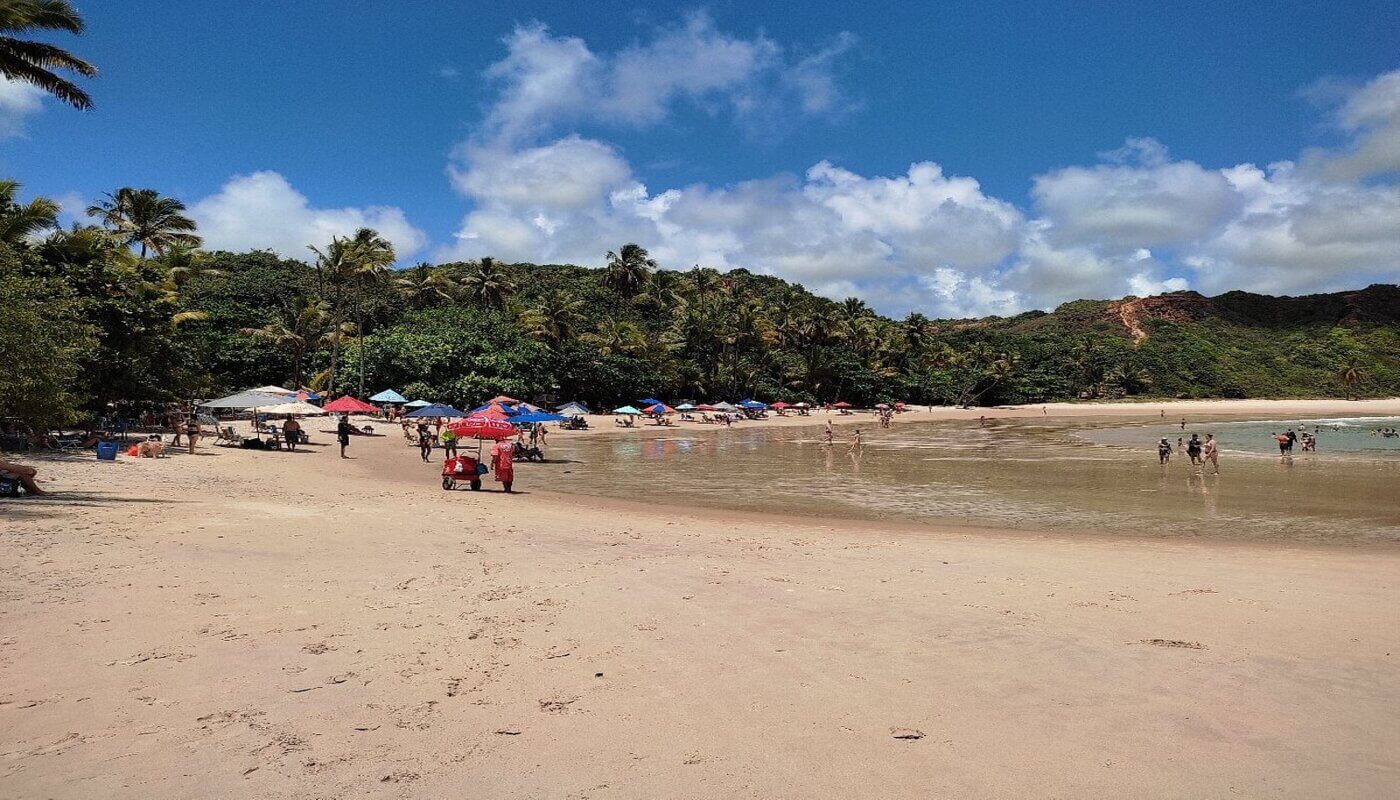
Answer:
[{"left": 0, "top": 182, "right": 1400, "bottom": 426}]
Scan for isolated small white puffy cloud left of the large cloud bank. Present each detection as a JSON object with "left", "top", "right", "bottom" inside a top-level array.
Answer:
[{"left": 189, "top": 172, "right": 427, "bottom": 261}]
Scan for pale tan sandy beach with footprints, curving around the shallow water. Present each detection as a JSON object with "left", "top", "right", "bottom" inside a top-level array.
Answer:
[{"left": 0, "top": 401, "right": 1400, "bottom": 799}]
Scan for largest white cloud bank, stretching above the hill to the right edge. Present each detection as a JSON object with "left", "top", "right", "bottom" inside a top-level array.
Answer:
[{"left": 437, "top": 15, "right": 1400, "bottom": 317}]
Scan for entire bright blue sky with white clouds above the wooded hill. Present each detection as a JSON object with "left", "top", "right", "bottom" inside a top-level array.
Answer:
[{"left": 0, "top": 0, "right": 1400, "bottom": 315}]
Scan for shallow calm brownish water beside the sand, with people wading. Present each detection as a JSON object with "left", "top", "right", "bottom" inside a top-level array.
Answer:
[{"left": 532, "top": 418, "right": 1400, "bottom": 544}]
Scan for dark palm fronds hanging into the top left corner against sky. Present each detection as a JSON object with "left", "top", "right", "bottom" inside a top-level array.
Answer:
[{"left": 0, "top": 0, "right": 97, "bottom": 109}]
